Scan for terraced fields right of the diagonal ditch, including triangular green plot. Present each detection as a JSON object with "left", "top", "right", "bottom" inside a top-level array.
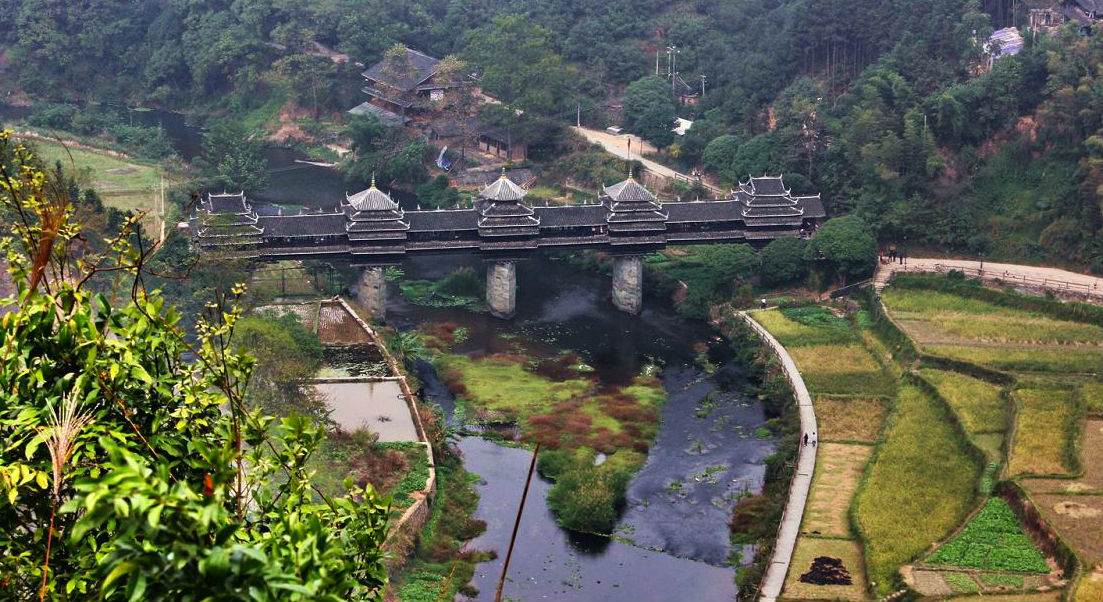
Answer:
[{"left": 884, "top": 275, "right": 1103, "bottom": 601}]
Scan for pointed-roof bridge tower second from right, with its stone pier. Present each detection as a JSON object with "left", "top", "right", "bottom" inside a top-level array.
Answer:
[{"left": 602, "top": 172, "right": 667, "bottom": 314}]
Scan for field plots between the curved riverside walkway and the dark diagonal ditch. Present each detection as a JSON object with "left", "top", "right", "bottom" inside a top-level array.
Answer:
[{"left": 751, "top": 308, "right": 979, "bottom": 600}]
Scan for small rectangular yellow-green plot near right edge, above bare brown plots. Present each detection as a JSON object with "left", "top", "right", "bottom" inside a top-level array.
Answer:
[{"left": 1009, "top": 389, "right": 1077, "bottom": 474}]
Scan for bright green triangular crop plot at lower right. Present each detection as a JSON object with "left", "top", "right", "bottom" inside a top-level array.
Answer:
[{"left": 927, "top": 498, "right": 1049, "bottom": 573}]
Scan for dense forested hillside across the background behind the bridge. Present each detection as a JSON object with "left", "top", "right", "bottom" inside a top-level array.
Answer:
[{"left": 0, "top": 0, "right": 1103, "bottom": 271}]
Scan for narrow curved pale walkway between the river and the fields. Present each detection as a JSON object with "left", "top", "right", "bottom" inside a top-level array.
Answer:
[{"left": 739, "top": 312, "right": 817, "bottom": 602}]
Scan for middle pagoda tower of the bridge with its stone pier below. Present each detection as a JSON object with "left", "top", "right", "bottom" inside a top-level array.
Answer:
[{"left": 475, "top": 170, "right": 540, "bottom": 319}]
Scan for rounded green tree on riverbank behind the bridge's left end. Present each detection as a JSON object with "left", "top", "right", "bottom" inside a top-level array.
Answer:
[{"left": 199, "top": 121, "right": 268, "bottom": 194}]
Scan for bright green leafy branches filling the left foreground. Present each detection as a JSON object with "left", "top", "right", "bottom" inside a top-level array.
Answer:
[{"left": 0, "top": 132, "right": 389, "bottom": 602}]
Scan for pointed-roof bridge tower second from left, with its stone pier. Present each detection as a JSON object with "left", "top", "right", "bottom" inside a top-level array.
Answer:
[{"left": 342, "top": 176, "right": 410, "bottom": 322}]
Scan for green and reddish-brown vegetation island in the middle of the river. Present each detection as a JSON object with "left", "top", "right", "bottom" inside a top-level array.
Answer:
[{"left": 436, "top": 339, "right": 666, "bottom": 533}]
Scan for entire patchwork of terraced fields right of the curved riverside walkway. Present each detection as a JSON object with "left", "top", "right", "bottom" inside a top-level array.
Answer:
[{"left": 750, "top": 276, "right": 1103, "bottom": 601}]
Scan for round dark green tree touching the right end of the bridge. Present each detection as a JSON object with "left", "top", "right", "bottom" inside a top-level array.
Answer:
[{"left": 804, "top": 215, "right": 877, "bottom": 284}]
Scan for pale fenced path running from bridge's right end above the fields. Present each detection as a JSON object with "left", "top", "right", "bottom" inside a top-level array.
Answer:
[{"left": 874, "top": 257, "right": 1103, "bottom": 299}]
